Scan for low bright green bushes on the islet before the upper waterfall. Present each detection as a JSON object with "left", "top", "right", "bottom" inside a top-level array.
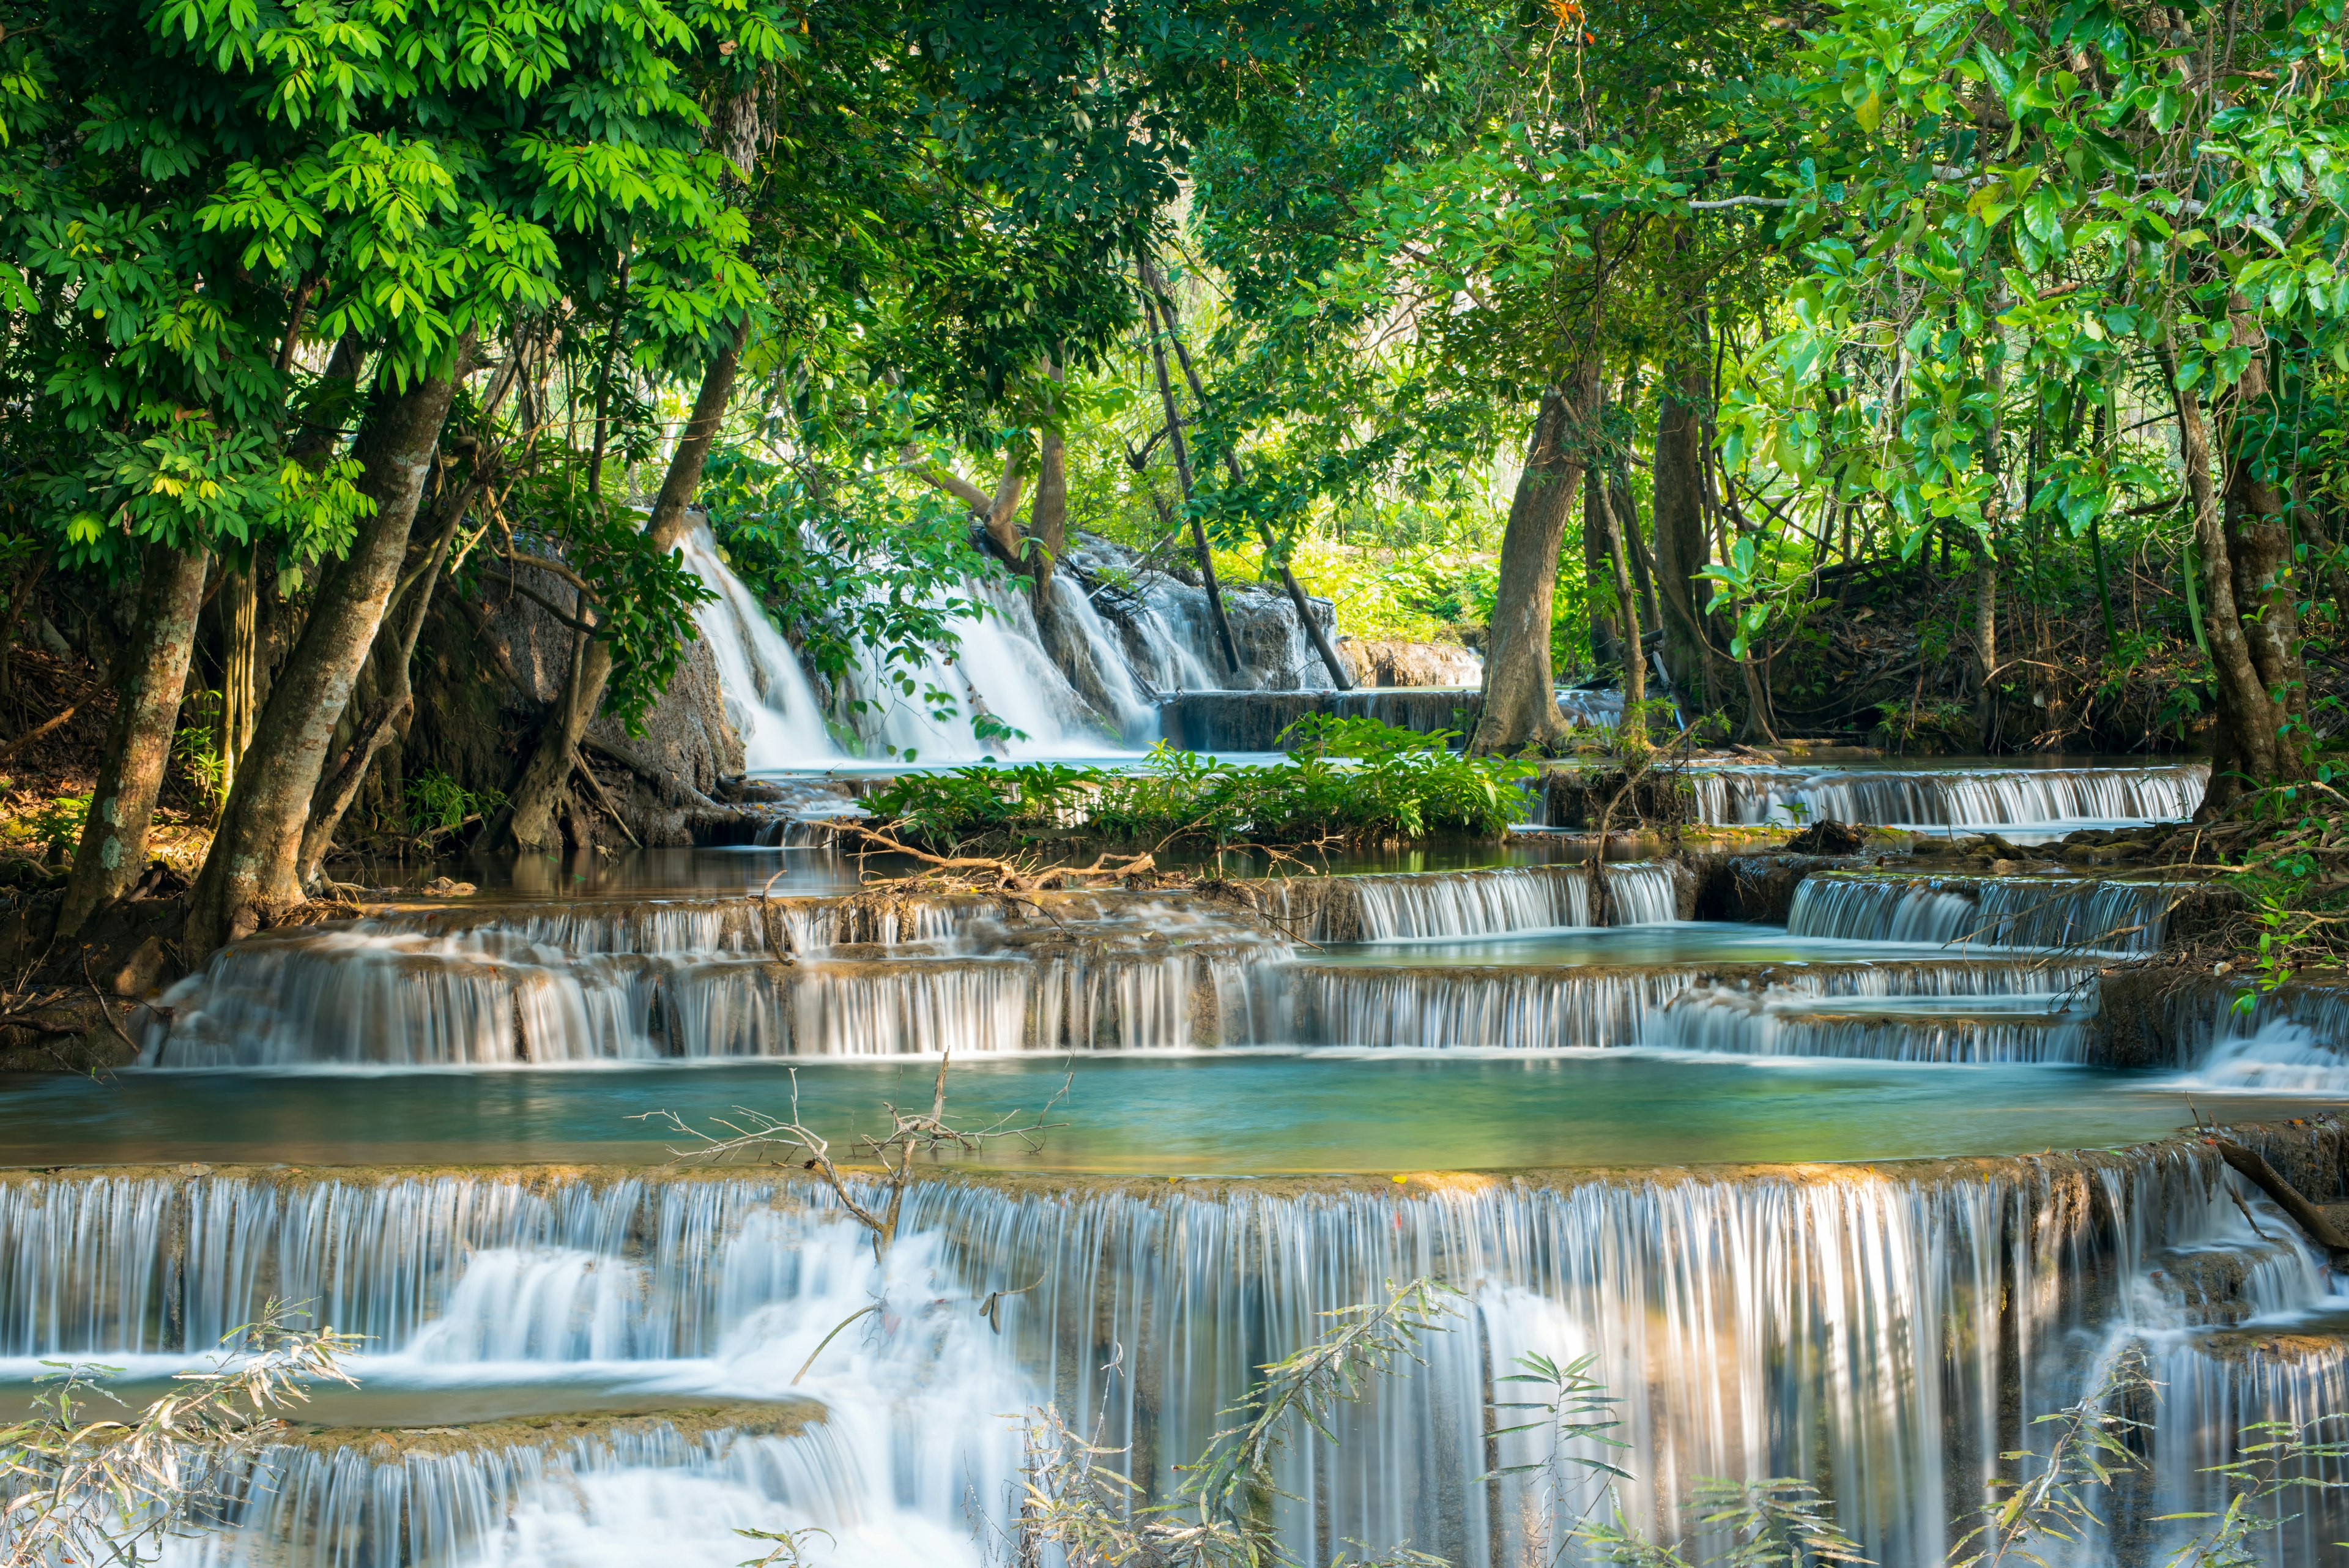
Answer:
[{"left": 869, "top": 715, "right": 1538, "bottom": 846}]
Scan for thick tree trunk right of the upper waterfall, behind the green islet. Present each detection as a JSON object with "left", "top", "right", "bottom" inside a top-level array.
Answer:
[{"left": 1471, "top": 365, "right": 1597, "bottom": 752}]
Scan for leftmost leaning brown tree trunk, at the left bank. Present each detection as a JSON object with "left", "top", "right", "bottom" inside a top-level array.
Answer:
[{"left": 56, "top": 543, "right": 204, "bottom": 938}]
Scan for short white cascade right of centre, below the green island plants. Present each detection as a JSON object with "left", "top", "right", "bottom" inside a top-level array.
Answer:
[{"left": 1233, "top": 860, "right": 1694, "bottom": 943}]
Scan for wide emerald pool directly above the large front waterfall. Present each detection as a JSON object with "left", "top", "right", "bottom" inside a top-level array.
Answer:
[{"left": 0, "top": 1051, "right": 2316, "bottom": 1175}]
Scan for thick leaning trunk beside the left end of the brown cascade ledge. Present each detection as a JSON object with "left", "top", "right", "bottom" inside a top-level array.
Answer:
[{"left": 185, "top": 345, "right": 472, "bottom": 959}]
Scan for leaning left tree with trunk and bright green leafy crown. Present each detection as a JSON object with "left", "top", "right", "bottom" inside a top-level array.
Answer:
[{"left": 114, "top": 0, "right": 796, "bottom": 949}]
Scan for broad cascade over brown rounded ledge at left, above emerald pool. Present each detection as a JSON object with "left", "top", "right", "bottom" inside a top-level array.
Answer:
[{"left": 143, "top": 896, "right": 1287, "bottom": 1068}]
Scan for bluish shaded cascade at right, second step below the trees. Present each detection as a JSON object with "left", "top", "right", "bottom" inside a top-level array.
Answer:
[{"left": 1787, "top": 872, "right": 2196, "bottom": 954}]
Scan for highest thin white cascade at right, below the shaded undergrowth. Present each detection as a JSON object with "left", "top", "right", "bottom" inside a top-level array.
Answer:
[{"left": 1689, "top": 762, "right": 2210, "bottom": 828}]
